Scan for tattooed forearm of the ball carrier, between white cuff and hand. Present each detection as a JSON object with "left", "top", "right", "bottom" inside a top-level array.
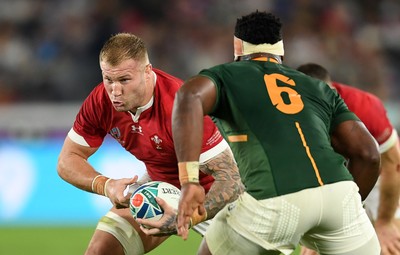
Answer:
[{"left": 200, "top": 148, "right": 244, "bottom": 219}]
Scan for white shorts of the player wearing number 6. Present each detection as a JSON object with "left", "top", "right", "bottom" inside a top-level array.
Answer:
[{"left": 205, "top": 181, "right": 380, "bottom": 255}]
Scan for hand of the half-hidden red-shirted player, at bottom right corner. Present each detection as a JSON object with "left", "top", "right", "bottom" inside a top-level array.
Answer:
[{"left": 375, "top": 220, "right": 400, "bottom": 255}]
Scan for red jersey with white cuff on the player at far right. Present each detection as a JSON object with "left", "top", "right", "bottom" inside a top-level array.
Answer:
[{"left": 332, "top": 82, "right": 398, "bottom": 153}]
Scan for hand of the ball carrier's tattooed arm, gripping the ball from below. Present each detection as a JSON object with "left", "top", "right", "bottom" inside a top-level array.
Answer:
[{"left": 136, "top": 197, "right": 176, "bottom": 236}]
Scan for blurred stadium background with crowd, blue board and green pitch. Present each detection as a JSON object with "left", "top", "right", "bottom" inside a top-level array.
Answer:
[{"left": 0, "top": 0, "right": 400, "bottom": 255}]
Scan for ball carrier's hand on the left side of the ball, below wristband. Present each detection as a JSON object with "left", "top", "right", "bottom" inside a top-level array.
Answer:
[{"left": 106, "top": 175, "right": 138, "bottom": 209}]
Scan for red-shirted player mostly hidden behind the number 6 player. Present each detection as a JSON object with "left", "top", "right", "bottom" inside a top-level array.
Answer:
[{"left": 297, "top": 63, "right": 400, "bottom": 255}]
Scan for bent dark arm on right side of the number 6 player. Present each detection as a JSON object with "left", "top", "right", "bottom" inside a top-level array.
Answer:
[{"left": 332, "top": 120, "right": 380, "bottom": 200}]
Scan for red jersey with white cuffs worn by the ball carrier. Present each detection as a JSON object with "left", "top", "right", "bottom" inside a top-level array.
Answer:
[{"left": 68, "top": 69, "right": 228, "bottom": 191}]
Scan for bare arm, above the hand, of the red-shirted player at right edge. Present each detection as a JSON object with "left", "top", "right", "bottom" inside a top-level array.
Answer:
[{"left": 378, "top": 143, "right": 400, "bottom": 222}]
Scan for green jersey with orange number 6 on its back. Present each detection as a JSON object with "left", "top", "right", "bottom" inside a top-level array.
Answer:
[{"left": 200, "top": 60, "right": 358, "bottom": 199}]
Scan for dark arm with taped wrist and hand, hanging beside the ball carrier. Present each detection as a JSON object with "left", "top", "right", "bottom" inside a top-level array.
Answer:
[{"left": 172, "top": 76, "right": 220, "bottom": 239}]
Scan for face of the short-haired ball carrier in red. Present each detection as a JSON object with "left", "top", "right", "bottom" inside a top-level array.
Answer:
[{"left": 100, "top": 59, "right": 153, "bottom": 112}]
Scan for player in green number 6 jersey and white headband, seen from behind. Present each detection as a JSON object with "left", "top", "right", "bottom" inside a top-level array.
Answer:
[{"left": 172, "top": 11, "right": 380, "bottom": 255}]
